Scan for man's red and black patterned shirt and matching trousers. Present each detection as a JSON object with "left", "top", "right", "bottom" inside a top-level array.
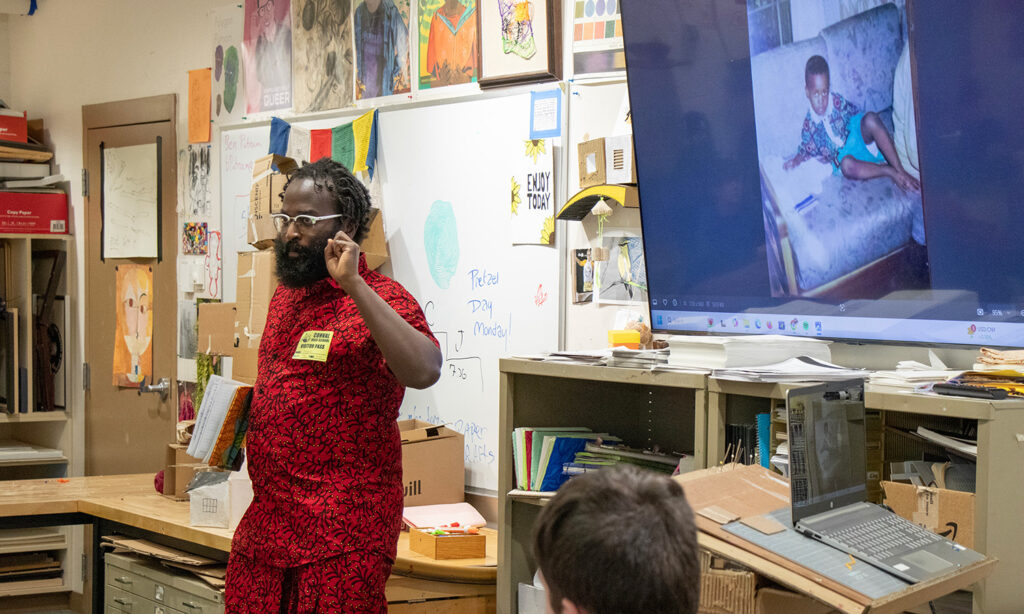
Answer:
[{"left": 225, "top": 255, "right": 437, "bottom": 614}]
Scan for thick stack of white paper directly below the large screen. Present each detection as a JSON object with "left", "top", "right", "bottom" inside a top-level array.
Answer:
[{"left": 669, "top": 335, "right": 831, "bottom": 368}]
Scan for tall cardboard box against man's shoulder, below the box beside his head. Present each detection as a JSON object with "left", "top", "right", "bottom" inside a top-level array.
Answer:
[{"left": 230, "top": 252, "right": 278, "bottom": 357}]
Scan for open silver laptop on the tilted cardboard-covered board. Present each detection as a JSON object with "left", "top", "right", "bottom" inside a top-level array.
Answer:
[{"left": 785, "top": 380, "right": 984, "bottom": 582}]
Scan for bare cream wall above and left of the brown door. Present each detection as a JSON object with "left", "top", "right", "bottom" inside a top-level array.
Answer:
[{"left": 6, "top": 0, "right": 237, "bottom": 474}]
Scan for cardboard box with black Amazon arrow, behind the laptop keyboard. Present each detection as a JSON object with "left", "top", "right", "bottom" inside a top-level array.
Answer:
[{"left": 882, "top": 482, "right": 975, "bottom": 550}]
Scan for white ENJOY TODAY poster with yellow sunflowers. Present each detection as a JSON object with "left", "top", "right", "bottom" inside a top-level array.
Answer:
[{"left": 512, "top": 139, "right": 555, "bottom": 246}]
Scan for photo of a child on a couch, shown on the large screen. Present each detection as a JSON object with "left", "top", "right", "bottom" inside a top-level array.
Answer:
[{"left": 748, "top": 0, "right": 930, "bottom": 302}]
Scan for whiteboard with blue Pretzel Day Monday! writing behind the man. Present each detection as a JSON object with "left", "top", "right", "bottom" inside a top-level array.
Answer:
[{"left": 221, "top": 92, "right": 559, "bottom": 491}]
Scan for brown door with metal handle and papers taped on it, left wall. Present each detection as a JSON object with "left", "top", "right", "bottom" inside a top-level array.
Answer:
[{"left": 81, "top": 95, "right": 177, "bottom": 476}]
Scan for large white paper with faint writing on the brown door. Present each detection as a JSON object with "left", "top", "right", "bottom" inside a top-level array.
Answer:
[{"left": 103, "top": 143, "right": 160, "bottom": 258}]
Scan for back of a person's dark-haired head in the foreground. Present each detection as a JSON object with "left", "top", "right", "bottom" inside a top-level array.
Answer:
[{"left": 534, "top": 466, "right": 700, "bottom": 614}]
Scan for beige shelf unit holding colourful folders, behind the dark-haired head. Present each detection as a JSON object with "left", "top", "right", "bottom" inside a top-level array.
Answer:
[{"left": 498, "top": 358, "right": 707, "bottom": 614}]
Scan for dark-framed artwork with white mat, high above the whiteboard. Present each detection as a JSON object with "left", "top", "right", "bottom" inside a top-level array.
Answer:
[{"left": 477, "top": 0, "right": 562, "bottom": 88}]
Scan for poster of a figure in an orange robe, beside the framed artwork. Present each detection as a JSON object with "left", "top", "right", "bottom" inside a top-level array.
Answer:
[{"left": 427, "top": 0, "right": 478, "bottom": 87}]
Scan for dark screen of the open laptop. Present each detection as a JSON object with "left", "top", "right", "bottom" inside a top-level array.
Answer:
[{"left": 786, "top": 380, "right": 867, "bottom": 523}]
